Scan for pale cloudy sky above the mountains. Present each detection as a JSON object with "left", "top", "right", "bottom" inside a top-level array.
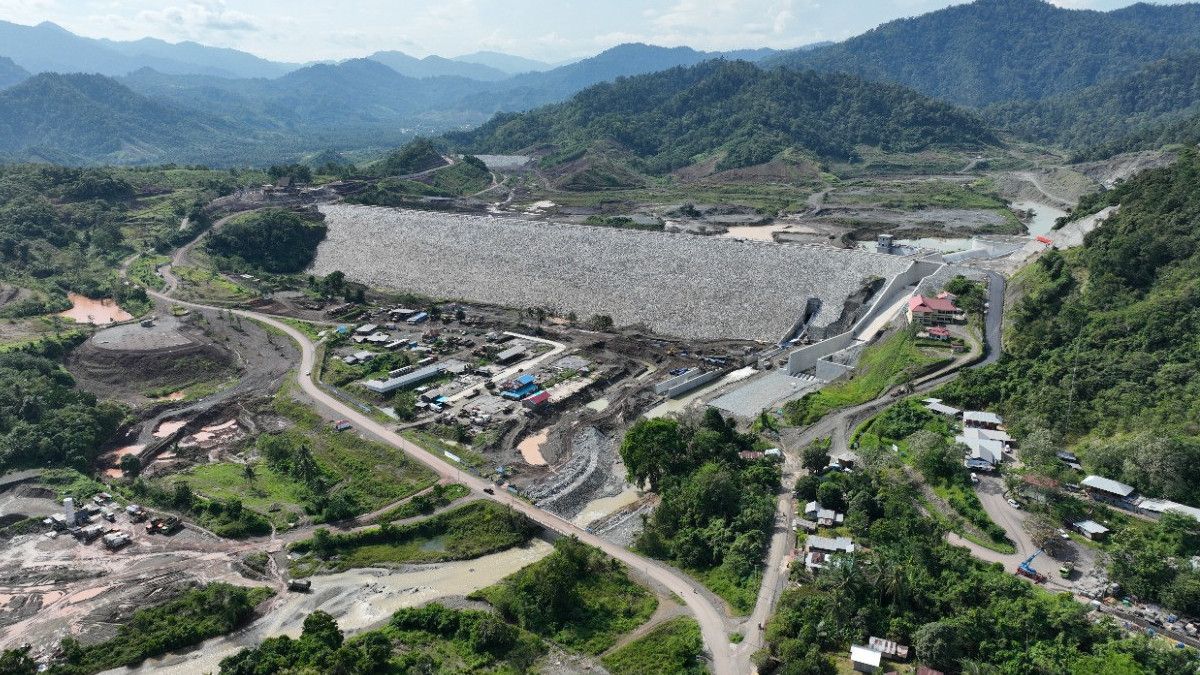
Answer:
[{"left": 0, "top": 0, "right": 1182, "bottom": 62}]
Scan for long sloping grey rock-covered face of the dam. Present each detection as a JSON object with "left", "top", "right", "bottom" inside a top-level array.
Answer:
[{"left": 312, "top": 204, "right": 908, "bottom": 341}]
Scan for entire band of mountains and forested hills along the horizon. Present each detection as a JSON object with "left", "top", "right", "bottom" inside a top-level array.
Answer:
[{"left": 0, "top": 0, "right": 1200, "bottom": 165}]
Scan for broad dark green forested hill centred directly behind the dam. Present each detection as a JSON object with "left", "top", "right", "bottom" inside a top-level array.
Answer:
[{"left": 450, "top": 60, "right": 996, "bottom": 173}]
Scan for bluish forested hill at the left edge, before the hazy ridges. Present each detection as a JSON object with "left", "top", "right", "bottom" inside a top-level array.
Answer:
[{"left": 0, "top": 73, "right": 243, "bottom": 163}]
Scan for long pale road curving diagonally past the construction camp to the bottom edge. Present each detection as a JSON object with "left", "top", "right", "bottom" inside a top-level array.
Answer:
[{"left": 133, "top": 278, "right": 729, "bottom": 675}]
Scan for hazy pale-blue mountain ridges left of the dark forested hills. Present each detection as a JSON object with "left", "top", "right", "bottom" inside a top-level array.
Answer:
[{"left": 0, "top": 44, "right": 787, "bottom": 166}]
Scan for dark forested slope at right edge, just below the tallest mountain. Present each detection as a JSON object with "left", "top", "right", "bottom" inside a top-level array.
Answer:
[{"left": 984, "top": 52, "right": 1200, "bottom": 156}]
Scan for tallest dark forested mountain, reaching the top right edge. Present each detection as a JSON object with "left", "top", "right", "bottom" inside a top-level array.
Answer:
[{"left": 764, "top": 0, "right": 1200, "bottom": 106}]
